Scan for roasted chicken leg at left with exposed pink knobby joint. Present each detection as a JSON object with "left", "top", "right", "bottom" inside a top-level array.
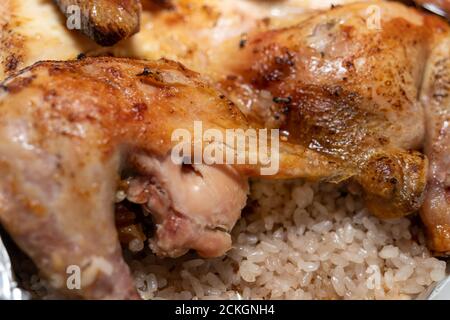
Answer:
[{"left": 0, "top": 58, "right": 320, "bottom": 299}]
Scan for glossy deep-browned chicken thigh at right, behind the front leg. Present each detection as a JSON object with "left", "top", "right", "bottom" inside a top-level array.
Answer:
[{"left": 214, "top": 1, "right": 448, "bottom": 218}]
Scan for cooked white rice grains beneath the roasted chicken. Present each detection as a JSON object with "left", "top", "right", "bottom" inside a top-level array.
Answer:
[{"left": 126, "top": 180, "right": 446, "bottom": 299}]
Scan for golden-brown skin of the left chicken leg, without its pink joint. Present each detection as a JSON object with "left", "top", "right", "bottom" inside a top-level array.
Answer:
[{"left": 0, "top": 58, "right": 339, "bottom": 299}]
